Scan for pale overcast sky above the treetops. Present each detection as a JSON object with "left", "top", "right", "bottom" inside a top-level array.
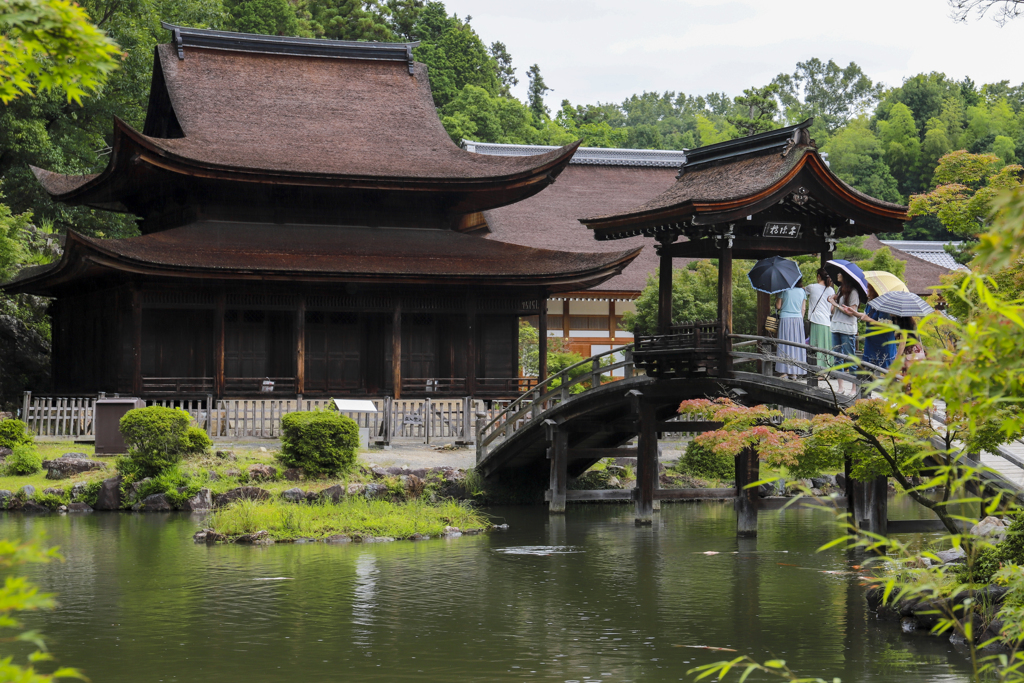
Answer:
[{"left": 445, "top": 0, "right": 1024, "bottom": 110}]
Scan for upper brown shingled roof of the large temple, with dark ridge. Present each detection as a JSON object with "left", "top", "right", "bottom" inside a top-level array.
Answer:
[{"left": 28, "top": 25, "right": 577, "bottom": 229}]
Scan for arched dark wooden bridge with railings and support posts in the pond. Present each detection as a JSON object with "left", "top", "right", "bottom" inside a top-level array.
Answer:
[{"left": 476, "top": 323, "right": 1024, "bottom": 535}]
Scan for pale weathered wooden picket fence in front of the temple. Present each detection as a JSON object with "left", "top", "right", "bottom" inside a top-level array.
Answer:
[{"left": 22, "top": 392, "right": 491, "bottom": 444}]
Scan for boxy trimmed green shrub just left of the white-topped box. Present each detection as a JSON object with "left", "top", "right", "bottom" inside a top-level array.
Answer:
[{"left": 278, "top": 411, "right": 359, "bottom": 476}]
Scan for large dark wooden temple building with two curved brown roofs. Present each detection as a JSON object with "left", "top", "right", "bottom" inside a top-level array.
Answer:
[{"left": 4, "top": 25, "right": 639, "bottom": 398}]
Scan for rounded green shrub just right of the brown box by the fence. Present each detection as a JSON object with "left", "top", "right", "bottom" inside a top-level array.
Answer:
[{"left": 118, "top": 405, "right": 196, "bottom": 480}]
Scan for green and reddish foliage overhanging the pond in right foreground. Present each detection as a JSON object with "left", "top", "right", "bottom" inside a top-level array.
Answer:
[{"left": 681, "top": 186, "right": 1024, "bottom": 683}]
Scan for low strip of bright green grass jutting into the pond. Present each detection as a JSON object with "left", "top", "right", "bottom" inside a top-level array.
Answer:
[{"left": 208, "top": 498, "right": 490, "bottom": 541}]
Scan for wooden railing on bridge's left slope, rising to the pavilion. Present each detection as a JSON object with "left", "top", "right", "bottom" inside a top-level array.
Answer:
[{"left": 476, "top": 344, "right": 633, "bottom": 462}]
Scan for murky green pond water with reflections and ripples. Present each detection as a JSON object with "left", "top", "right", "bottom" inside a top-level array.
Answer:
[{"left": 0, "top": 501, "right": 967, "bottom": 683}]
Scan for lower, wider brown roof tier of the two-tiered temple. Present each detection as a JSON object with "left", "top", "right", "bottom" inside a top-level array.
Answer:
[{"left": 4, "top": 222, "right": 640, "bottom": 296}]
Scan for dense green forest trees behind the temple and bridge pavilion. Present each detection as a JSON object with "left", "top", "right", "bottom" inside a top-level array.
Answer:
[{"left": 0, "top": 0, "right": 1024, "bottom": 395}]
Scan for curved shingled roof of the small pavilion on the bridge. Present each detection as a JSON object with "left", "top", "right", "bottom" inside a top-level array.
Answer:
[{"left": 580, "top": 121, "right": 906, "bottom": 240}]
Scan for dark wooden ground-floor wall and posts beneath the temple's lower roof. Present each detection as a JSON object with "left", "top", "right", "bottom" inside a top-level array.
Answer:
[{"left": 51, "top": 283, "right": 541, "bottom": 396}]
